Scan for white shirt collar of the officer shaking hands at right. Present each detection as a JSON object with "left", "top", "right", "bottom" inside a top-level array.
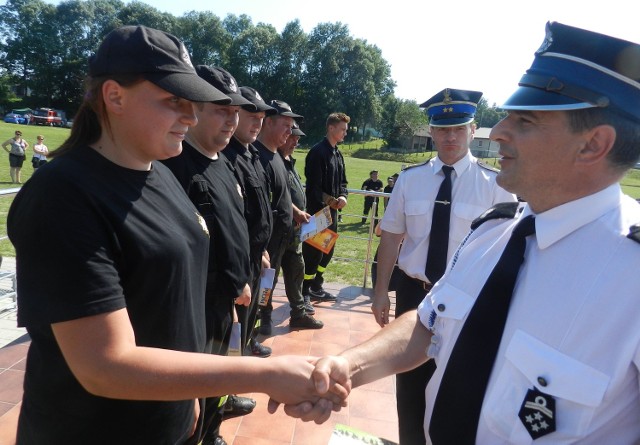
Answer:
[{"left": 521, "top": 183, "right": 622, "bottom": 249}]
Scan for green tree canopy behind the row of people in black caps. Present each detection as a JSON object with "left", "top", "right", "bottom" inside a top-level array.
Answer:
[{"left": 0, "top": 0, "right": 504, "bottom": 140}]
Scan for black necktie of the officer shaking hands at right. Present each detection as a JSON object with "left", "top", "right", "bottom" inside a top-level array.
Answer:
[{"left": 429, "top": 215, "right": 535, "bottom": 445}]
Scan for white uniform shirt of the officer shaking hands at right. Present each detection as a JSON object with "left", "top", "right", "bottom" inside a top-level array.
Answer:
[{"left": 418, "top": 184, "right": 640, "bottom": 445}]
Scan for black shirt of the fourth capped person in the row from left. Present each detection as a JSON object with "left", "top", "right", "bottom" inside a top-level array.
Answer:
[{"left": 255, "top": 141, "right": 293, "bottom": 254}]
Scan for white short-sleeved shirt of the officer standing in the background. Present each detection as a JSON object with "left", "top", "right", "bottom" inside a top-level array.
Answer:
[{"left": 380, "top": 152, "right": 516, "bottom": 281}]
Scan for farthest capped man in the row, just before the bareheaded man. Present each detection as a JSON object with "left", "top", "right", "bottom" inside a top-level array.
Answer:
[{"left": 255, "top": 100, "right": 323, "bottom": 335}]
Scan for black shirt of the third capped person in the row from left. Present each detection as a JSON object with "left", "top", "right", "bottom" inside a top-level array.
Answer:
[{"left": 222, "top": 137, "right": 273, "bottom": 258}]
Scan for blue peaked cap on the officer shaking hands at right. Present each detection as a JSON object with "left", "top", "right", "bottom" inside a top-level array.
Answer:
[{"left": 501, "top": 22, "right": 640, "bottom": 122}]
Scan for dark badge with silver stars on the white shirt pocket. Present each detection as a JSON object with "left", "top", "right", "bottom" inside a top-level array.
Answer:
[{"left": 518, "top": 388, "right": 556, "bottom": 440}]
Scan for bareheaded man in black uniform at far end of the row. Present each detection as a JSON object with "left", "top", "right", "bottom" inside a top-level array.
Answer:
[{"left": 302, "top": 113, "right": 351, "bottom": 301}]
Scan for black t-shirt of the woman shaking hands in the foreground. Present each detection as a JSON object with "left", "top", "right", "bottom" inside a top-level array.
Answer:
[{"left": 7, "top": 147, "right": 208, "bottom": 444}]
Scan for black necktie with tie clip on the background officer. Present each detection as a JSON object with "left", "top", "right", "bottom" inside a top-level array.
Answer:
[{"left": 424, "top": 165, "right": 453, "bottom": 283}]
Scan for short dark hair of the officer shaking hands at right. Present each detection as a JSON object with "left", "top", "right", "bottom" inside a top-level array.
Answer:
[{"left": 567, "top": 107, "right": 640, "bottom": 170}]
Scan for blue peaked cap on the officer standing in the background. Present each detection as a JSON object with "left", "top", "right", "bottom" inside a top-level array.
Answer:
[{"left": 420, "top": 88, "right": 482, "bottom": 127}]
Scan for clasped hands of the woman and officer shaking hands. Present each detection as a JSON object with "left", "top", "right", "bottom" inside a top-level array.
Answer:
[{"left": 262, "top": 356, "right": 351, "bottom": 424}]
